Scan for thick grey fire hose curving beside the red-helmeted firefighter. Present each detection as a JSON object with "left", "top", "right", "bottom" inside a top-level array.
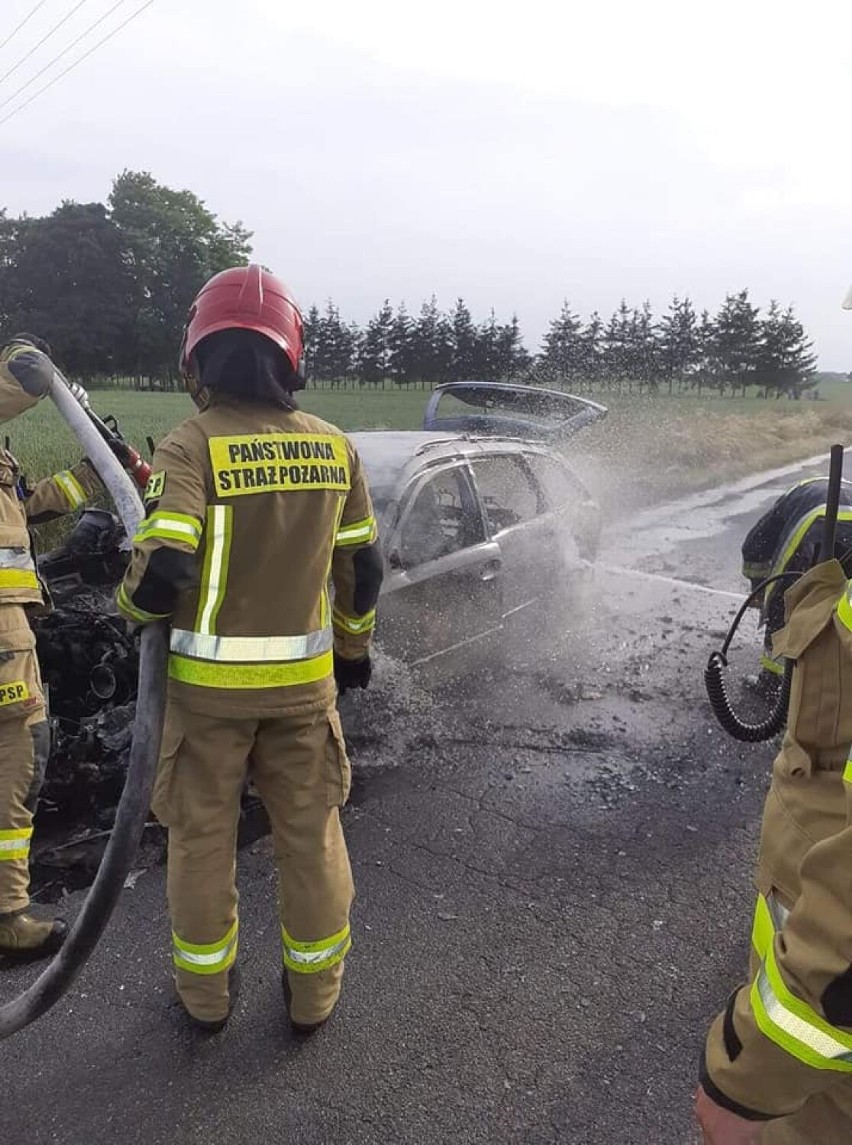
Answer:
[{"left": 0, "top": 371, "right": 168, "bottom": 1040}]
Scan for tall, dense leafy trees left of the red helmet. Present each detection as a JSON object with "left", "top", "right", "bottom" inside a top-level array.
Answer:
[{"left": 0, "top": 171, "right": 251, "bottom": 387}]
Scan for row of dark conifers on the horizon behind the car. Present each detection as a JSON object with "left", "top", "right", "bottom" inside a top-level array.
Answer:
[{"left": 306, "top": 290, "right": 817, "bottom": 397}]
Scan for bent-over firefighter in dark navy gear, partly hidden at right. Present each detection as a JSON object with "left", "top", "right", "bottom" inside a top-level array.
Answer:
[{"left": 742, "top": 477, "right": 852, "bottom": 692}]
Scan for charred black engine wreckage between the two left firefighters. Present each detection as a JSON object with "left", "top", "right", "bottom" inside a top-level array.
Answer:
[{"left": 31, "top": 510, "right": 268, "bottom": 900}]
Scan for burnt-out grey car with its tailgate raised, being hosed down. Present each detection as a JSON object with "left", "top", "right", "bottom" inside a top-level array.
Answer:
[{"left": 352, "top": 381, "right": 606, "bottom": 671}]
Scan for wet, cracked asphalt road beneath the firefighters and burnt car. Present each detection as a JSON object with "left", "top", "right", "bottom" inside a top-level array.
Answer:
[{"left": 0, "top": 455, "right": 833, "bottom": 1145}]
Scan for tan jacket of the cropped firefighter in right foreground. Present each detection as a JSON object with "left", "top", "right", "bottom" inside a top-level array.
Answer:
[{"left": 702, "top": 561, "right": 852, "bottom": 1122}]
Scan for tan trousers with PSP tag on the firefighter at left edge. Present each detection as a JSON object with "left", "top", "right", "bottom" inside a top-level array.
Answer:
[{"left": 0, "top": 605, "right": 50, "bottom": 915}]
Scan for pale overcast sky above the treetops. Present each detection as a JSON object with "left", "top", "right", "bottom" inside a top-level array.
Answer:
[{"left": 0, "top": 0, "right": 852, "bottom": 370}]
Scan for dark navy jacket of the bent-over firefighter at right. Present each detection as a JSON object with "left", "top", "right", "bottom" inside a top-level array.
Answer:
[{"left": 742, "top": 477, "right": 852, "bottom": 599}]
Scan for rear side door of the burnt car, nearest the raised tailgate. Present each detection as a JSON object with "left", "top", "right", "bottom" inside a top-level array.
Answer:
[{"left": 471, "top": 450, "right": 558, "bottom": 621}]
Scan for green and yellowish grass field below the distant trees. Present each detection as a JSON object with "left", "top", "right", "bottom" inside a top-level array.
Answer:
[{"left": 8, "top": 382, "right": 852, "bottom": 535}]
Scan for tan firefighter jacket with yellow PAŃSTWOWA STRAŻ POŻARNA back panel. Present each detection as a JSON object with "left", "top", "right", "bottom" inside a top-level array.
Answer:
[{"left": 117, "top": 395, "right": 381, "bottom": 717}]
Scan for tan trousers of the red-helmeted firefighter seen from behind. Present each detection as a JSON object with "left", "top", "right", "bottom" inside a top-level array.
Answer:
[{"left": 152, "top": 701, "right": 354, "bottom": 1025}]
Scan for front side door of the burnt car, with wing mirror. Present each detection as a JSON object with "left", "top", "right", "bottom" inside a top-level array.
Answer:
[{"left": 377, "top": 459, "right": 503, "bottom": 664}]
